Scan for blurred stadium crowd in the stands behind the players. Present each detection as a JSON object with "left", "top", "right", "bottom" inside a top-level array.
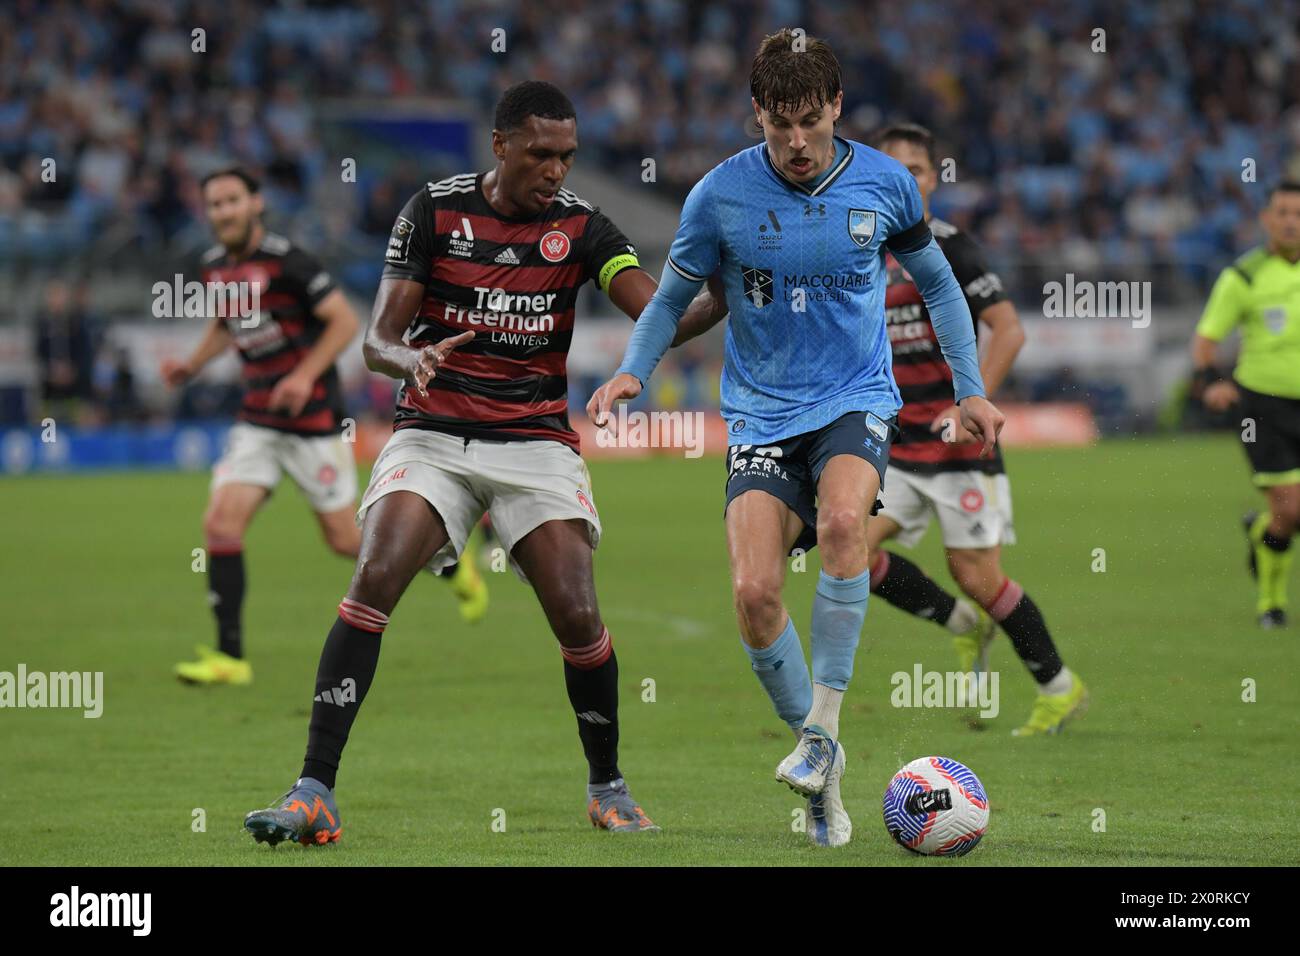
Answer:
[{"left": 0, "top": 0, "right": 1300, "bottom": 298}]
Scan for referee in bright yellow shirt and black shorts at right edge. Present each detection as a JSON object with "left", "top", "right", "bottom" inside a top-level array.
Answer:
[{"left": 1192, "top": 181, "right": 1300, "bottom": 628}]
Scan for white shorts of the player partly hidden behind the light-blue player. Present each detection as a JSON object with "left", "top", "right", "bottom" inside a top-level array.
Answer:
[{"left": 879, "top": 468, "right": 1015, "bottom": 548}]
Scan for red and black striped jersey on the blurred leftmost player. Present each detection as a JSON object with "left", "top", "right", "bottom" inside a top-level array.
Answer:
[{"left": 200, "top": 233, "right": 345, "bottom": 434}]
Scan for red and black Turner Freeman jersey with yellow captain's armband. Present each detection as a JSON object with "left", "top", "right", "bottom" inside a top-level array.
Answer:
[{"left": 384, "top": 173, "right": 638, "bottom": 451}]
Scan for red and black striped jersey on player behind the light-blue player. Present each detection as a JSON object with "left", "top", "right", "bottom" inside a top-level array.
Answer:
[{"left": 885, "top": 219, "right": 1006, "bottom": 475}]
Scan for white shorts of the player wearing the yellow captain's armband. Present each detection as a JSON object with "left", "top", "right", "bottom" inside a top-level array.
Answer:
[{"left": 356, "top": 428, "right": 601, "bottom": 580}]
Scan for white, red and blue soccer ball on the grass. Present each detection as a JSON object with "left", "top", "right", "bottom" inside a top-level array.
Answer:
[{"left": 884, "top": 757, "right": 988, "bottom": 856}]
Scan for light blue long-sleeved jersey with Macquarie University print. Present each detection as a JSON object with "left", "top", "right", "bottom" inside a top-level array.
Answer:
[{"left": 619, "top": 138, "right": 983, "bottom": 444}]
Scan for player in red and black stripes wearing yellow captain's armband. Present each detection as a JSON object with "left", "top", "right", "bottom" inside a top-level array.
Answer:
[{"left": 244, "top": 81, "right": 733, "bottom": 843}]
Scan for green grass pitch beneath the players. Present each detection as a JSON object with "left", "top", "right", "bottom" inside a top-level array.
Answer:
[{"left": 0, "top": 438, "right": 1300, "bottom": 866}]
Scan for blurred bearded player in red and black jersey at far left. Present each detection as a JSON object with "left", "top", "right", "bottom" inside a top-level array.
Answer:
[{"left": 161, "top": 168, "right": 488, "bottom": 684}]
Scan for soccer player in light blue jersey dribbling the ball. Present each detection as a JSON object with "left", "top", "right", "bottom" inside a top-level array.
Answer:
[{"left": 588, "top": 30, "right": 1002, "bottom": 845}]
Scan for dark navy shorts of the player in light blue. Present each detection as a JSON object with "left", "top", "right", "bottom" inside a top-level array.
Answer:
[{"left": 723, "top": 411, "right": 898, "bottom": 551}]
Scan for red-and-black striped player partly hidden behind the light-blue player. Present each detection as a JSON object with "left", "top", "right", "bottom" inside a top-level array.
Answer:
[{"left": 867, "top": 124, "right": 1087, "bottom": 736}]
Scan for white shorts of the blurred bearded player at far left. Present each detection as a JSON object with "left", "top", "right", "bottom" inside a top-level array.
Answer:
[{"left": 212, "top": 421, "right": 356, "bottom": 514}]
